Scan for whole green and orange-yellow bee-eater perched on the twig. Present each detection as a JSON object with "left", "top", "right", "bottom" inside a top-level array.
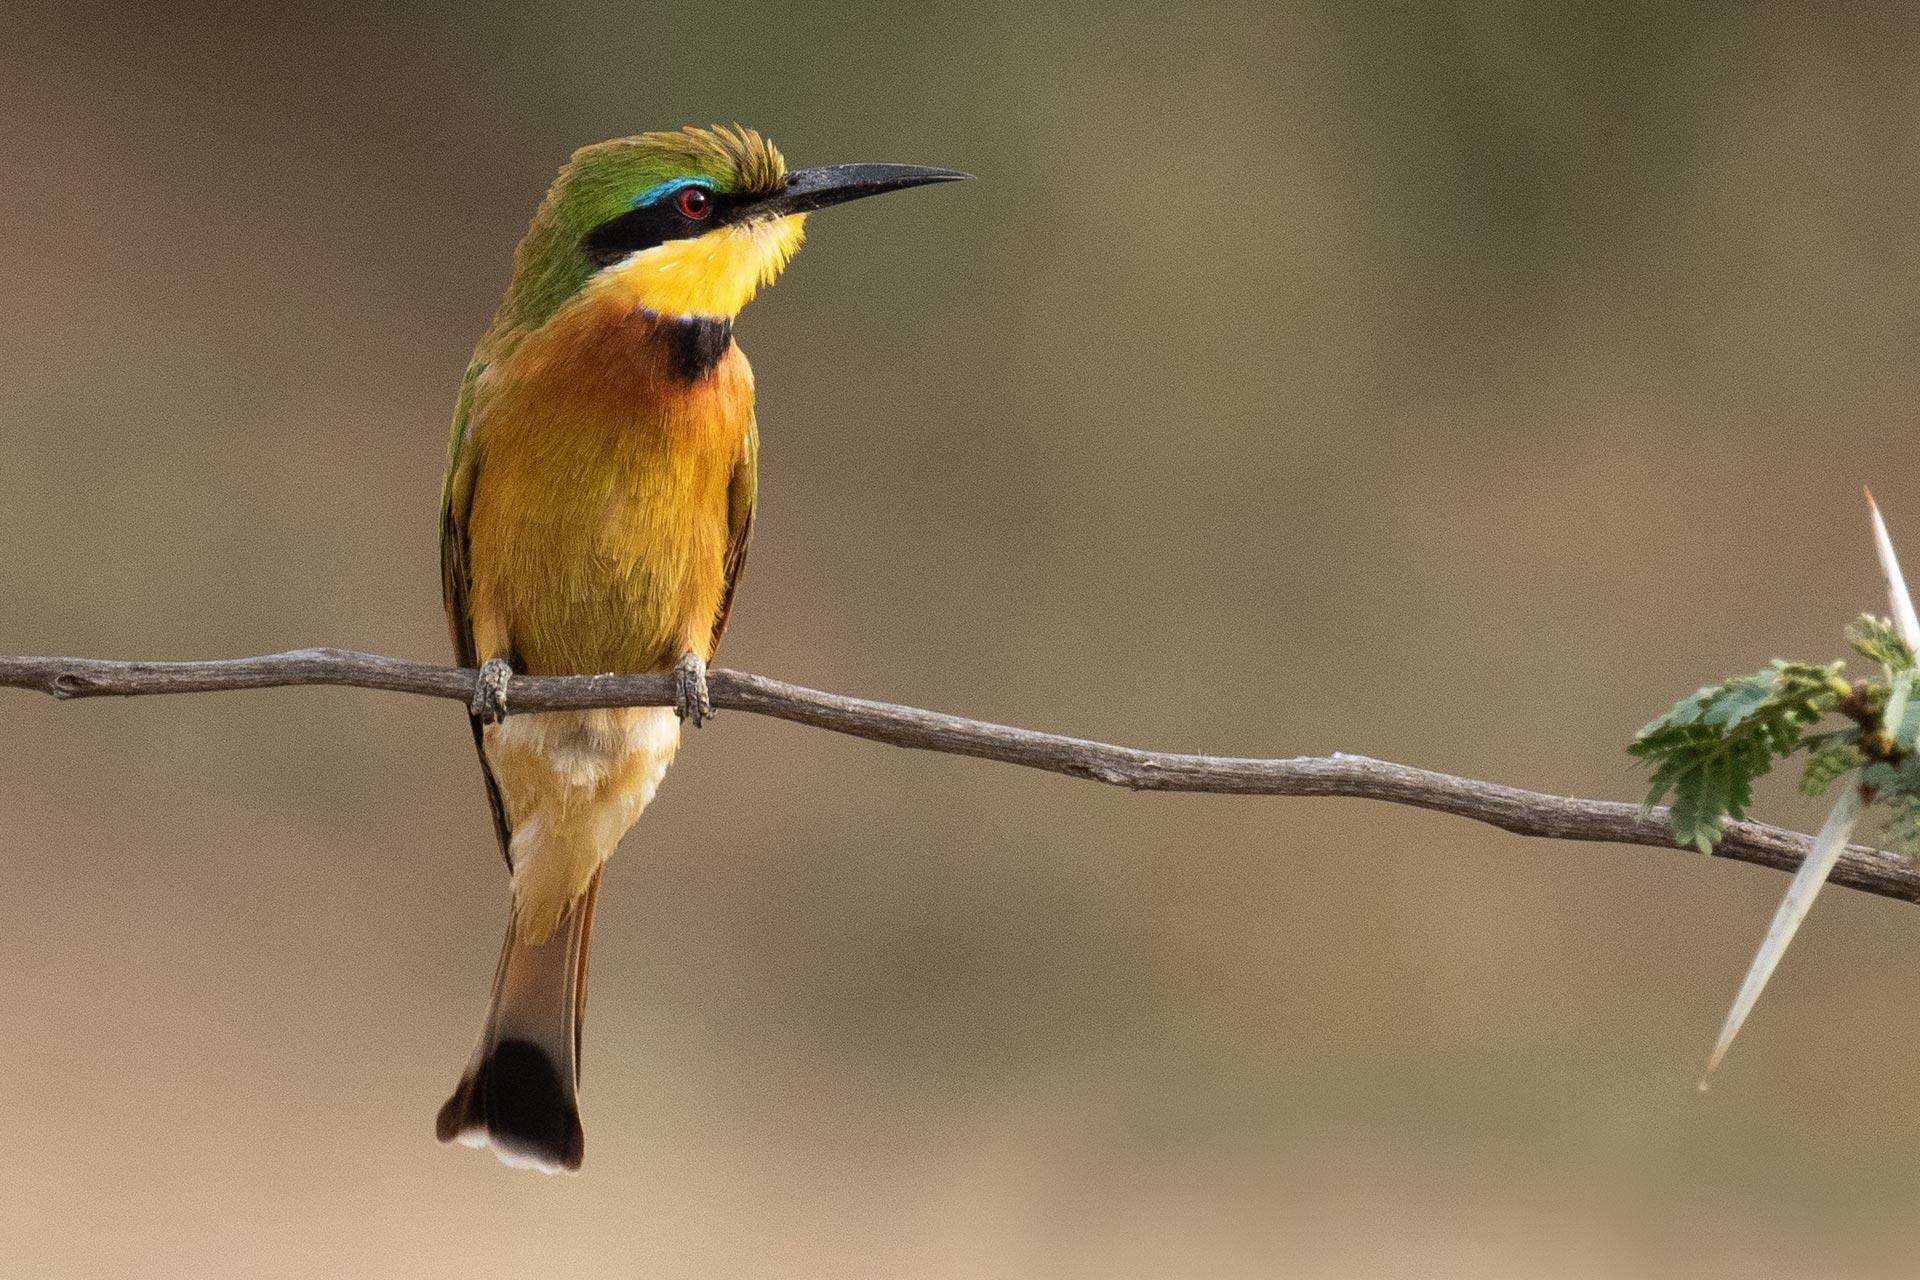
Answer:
[{"left": 436, "top": 127, "right": 968, "bottom": 1173}]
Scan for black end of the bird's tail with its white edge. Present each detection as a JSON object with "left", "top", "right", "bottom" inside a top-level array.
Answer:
[{"left": 434, "top": 1040, "right": 588, "bottom": 1173}]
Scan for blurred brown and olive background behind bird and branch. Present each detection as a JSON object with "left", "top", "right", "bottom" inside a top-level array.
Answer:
[{"left": 0, "top": 0, "right": 1920, "bottom": 1278}]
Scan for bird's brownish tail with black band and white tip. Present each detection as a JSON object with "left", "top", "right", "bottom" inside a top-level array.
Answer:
[{"left": 434, "top": 871, "right": 599, "bottom": 1173}]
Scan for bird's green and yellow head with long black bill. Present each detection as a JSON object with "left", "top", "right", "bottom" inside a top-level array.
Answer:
[{"left": 499, "top": 125, "right": 968, "bottom": 328}]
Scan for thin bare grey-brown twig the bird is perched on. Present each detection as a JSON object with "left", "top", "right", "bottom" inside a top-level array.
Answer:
[{"left": 0, "top": 649, "right": 1920, "bottom": 902}]
